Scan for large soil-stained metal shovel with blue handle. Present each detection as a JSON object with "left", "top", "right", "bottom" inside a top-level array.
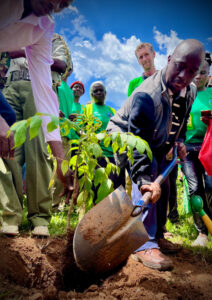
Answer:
[{"left": 73, "top": 149, "right": 177, "bottom": 273}]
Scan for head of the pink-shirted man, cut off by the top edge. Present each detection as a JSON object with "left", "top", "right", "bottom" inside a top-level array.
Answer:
[{"left": 30, "top": 0, "right": 73, "bottom": 17}]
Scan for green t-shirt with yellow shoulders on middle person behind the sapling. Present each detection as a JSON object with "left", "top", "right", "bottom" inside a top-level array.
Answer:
[{"left": 85, "top": 103, "right": 115, "bottom": 157}]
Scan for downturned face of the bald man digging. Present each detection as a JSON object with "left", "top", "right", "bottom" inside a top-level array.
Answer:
[{"left": 166, "top": 51, "right": 202, "bottom": 93}]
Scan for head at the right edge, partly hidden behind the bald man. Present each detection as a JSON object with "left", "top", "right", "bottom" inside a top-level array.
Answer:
[{"left": 194, "top": 52, "right": 211, "bottom": 91}]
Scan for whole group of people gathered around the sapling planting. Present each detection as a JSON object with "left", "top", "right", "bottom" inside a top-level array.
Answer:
[{"left": 0, "top": 0, "right": 212, "bottom": 270}]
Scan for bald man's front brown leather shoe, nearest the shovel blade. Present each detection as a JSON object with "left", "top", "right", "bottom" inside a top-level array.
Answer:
[{"left": 131, "top": 249, "right": 173, "bottom": 271}]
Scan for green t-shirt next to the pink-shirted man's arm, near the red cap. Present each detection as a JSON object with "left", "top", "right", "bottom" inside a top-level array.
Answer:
[{"left": 58, "top": 81, "right": 83, "bottom": 140}]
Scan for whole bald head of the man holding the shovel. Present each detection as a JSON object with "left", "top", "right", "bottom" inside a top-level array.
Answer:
[{"left": 166, "top": 39, "right": 205, "bottom": 94}]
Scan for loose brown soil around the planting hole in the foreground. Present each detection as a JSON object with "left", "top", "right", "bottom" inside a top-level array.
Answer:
[{"left": 0, "top": 231, "right": 212, "bottom": 300}]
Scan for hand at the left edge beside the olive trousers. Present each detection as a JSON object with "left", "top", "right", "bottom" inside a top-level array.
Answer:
[{"left": 0, "top": 116, "right": 15, "bottom": 159}]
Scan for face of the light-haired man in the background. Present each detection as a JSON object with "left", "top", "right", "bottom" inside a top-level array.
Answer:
[{"left": 136, "top": 46, "right": 155, "bottom": 71}]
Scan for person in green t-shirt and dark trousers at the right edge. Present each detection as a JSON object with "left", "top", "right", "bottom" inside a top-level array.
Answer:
[{"left": 182, "top": 53, "right": 212, "bottom": 246}]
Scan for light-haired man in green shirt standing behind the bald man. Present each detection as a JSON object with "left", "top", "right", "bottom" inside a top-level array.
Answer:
[{"left": 128, "top": 43, "right": 156, "bottom": 97}]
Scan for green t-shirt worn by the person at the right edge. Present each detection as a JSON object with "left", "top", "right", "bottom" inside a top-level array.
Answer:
[{"left": 185, "top": 87, "right": 212, "bottom": 144}]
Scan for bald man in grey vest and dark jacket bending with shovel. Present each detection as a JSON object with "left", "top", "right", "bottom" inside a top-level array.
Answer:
[{"left": 107, "top": 39, "right": 205, "bottom": 270}]
